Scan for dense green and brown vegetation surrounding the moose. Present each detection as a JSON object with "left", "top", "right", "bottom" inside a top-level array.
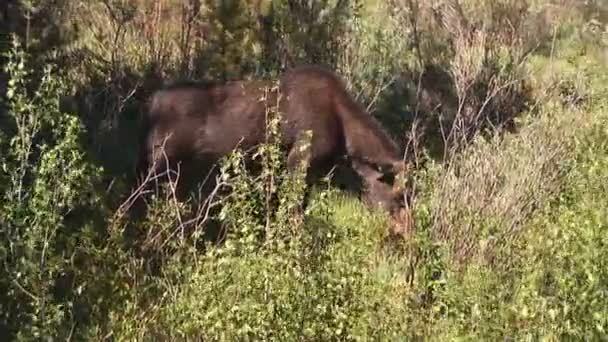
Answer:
[{"left": 0, "top": 0, "right": 608, "bottom": 341}]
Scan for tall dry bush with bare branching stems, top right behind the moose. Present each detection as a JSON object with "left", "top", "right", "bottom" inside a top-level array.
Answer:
[{"left": 393, "top": 0, "right": 558, "bottom": 160}]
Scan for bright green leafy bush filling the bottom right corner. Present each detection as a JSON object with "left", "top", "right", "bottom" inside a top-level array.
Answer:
[{"left": 426, "top": 97, "right": 608, "bottom": 340}]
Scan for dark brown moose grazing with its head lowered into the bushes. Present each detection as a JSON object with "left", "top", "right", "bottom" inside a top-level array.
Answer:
[{"left": 137, "top": 65, "right": 410, "bottom": 236}]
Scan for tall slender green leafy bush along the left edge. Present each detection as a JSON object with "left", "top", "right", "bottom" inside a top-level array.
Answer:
[{"left": 0, "top": 35, "right": 99, "bottom": 339}]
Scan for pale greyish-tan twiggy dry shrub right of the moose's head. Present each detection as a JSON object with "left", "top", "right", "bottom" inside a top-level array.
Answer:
[{"left": 431, "top": 104, "right": 585, "bottom": 261}]
